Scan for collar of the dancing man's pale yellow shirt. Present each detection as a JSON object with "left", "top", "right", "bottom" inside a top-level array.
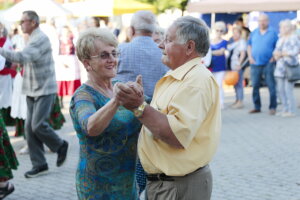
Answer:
[{"left": 165, "top": 57, "right": 201, "bottom": 80}]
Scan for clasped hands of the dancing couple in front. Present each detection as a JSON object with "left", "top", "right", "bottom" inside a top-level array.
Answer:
[{"left": 114, "top": 75, "right": 144, "bottom": 110}]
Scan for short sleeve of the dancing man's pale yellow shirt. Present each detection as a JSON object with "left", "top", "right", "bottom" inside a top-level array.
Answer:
[{"left": 167, "top": 81, "right": 213, "bottom": 148}]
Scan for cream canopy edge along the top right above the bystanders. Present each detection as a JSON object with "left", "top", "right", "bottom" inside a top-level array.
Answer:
[{"left": 187, "top": 0, "right": 300, "bottom": 14}]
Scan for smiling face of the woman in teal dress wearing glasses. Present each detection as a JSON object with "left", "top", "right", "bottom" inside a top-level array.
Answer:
[{"left": 85, "top": 40, "right": 118, "bottom": 79}]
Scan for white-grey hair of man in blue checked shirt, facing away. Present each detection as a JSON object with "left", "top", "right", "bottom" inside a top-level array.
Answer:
[{"left": 130, "top": 10, "right": 156, "bottom": 33}]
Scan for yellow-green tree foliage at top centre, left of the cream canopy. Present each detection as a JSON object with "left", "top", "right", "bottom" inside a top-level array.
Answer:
[{"left": 138, "top": 0, "right": 188, "bottom": 13}]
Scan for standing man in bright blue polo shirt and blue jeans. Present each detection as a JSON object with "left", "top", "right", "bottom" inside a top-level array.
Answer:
[{"left": 248, "top": 14, "right": 278, "bottom": 115}]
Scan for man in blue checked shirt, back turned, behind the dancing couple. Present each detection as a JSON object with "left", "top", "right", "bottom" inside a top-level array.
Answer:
[{"left": 116, "top": 11, "right": 168, "bottom": 98}]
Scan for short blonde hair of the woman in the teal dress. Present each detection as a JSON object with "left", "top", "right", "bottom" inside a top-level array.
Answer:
[{"left": 76, "top": 28, "right": 118, "bottom": 62}]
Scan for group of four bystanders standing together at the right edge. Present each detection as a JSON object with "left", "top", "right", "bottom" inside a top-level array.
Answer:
[{"left": 209, "top": 13, "right": 300, "bottom": 117}]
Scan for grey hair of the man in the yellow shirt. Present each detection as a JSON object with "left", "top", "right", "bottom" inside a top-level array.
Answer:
[{"left": 173, "top": 16, "right": 210, "bottom": 57}]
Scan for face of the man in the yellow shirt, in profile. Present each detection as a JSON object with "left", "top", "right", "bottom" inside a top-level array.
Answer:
[{"left": 159, "top": 26, "right": 186, "bottom": 70}]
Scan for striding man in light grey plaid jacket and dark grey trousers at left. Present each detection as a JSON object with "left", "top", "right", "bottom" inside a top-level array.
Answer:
[{"left": 0, "top": 11, "right": 68, "bottom": 178}]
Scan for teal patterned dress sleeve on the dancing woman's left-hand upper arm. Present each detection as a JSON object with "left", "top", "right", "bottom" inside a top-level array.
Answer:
[{"left": 70, "top": 91, "right": 97, "bottom": 135}]
